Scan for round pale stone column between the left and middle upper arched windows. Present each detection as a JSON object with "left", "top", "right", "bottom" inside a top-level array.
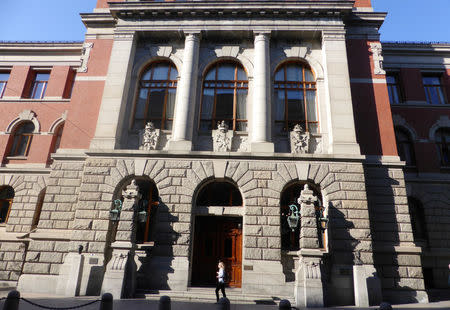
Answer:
[{"left": 169, "top": 32, "right": 200, "bottom": 151}]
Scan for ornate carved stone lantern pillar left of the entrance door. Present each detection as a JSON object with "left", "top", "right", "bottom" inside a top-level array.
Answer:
[{"left": 102, "top": 180, "right": 141, "bottom": 299}]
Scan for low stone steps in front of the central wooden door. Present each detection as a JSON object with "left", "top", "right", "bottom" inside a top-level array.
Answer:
[{"left": 144, "top": 287, "right": 294, "bottom": 305}]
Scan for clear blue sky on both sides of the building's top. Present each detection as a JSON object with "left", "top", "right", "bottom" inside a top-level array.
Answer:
[{"left": 0, "top": 0, "right": 450, "bottom": 42}]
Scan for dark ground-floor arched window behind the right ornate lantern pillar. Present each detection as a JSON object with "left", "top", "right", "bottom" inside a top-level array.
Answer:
[{"left": 280, "top": 182, "right": 325, "bottom": 250}]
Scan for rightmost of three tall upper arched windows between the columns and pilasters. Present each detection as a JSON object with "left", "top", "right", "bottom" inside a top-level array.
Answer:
[{"left": 274, "top": 62, "right": 319, "bottom": 133}]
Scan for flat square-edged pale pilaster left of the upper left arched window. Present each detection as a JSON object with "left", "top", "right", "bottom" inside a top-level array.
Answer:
[{"left": 90, "top": 33, "right": 136, "bottom": 150}]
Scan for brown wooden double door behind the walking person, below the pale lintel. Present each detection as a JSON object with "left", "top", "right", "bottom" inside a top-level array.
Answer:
[{"left": 191, "top": 216, "right": 242, "bottom": 287}]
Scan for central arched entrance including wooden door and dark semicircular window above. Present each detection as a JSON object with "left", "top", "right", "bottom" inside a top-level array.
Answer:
[{"left": 191, "top": 181, "right": 242, "bottom": 287}]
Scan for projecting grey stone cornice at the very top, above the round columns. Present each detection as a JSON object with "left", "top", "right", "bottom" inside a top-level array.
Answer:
[{"left": 109, "top": 0, "right": 353, "bottom": 19}]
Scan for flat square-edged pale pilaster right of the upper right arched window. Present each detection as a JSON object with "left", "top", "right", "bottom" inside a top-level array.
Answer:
[{"left": 322, "top": 30, "right": 360, "bottom": 155}]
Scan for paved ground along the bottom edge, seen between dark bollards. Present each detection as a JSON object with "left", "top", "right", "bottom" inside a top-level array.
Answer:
[{"left": 0, "top": 295, "right": 450, "bottom": 310}]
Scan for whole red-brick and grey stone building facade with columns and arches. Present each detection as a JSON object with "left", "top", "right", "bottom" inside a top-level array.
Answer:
[{"left": 0, "top": 0, "right": 450, "bottom": 306}]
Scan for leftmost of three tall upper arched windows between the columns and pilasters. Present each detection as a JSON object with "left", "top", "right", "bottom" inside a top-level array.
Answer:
[{"left": 133, "top": 61, "right": 178, "bottom": 130}]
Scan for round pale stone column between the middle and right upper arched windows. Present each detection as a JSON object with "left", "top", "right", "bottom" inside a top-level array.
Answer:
[{"left": 251, "top": 32, "right": 274, "bottom": 152}]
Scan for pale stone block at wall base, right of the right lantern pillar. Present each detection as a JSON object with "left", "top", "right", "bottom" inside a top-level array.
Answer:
[{"left": 353, "top": 265, "right": 382, "bottom": 307}]
